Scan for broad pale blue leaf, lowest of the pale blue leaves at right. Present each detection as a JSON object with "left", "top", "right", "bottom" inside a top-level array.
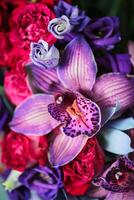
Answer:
[{"left": 100, "top": 128, "right": 133, "bottom": 155}]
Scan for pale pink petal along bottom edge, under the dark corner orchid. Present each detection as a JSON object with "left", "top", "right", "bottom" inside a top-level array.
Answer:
[{"left": 105, "top": 191, "right": 134, "bottom": 200}]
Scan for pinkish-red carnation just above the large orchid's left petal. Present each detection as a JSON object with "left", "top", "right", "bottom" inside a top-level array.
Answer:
[{"left": 4, "top": 48, "right": 31, "bottom": 105}]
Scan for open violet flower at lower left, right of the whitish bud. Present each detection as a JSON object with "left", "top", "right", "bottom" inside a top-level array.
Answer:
[{"left": 19, "top": 166, "right": 63, "bottom": 200}]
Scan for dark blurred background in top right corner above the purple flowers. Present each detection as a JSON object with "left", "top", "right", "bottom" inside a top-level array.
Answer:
[{"left": 73, "top": 0, "right": 134, "bottom": 41}]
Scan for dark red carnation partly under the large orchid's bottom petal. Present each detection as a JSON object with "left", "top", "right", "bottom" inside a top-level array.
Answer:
[{"left": 63, "top": 138, "right": 104, "bottom": 196}]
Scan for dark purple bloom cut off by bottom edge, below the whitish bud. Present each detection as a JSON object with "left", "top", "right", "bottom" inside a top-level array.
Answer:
[{"left": 8, "top": 186, "right": 30, "bottom": 200}]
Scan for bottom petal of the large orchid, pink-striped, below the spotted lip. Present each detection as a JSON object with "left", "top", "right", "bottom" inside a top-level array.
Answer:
[{"left": 48, "top": 128, "right": 88, "bottom": 167}]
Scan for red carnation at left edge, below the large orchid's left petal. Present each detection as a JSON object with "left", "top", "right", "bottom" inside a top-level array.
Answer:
[{"left": 2, "top": 132, "right": 48, "bottom": 171}]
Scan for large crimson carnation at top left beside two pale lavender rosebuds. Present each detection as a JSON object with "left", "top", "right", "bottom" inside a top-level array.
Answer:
[{"left": 10, "top": 3, "right": 56, "bottom": 49}]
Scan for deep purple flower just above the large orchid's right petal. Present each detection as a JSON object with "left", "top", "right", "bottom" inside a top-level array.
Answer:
[{"left": 96, "top": 52, "right": 132, "bottom": 74}]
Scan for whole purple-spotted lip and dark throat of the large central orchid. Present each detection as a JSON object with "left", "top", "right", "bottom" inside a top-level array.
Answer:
[{"left": 48, "top": 92, "right": 101, "bottom": 137}]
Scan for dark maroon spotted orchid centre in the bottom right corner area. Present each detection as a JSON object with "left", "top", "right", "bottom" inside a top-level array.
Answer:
[{"left": 94, "top": 156, "right": 134, "bottom": 193}]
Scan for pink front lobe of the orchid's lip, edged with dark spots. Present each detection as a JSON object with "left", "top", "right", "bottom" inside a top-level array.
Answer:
[{"left": 64, "top": 95, "right": 101, "bottom": 137}]
